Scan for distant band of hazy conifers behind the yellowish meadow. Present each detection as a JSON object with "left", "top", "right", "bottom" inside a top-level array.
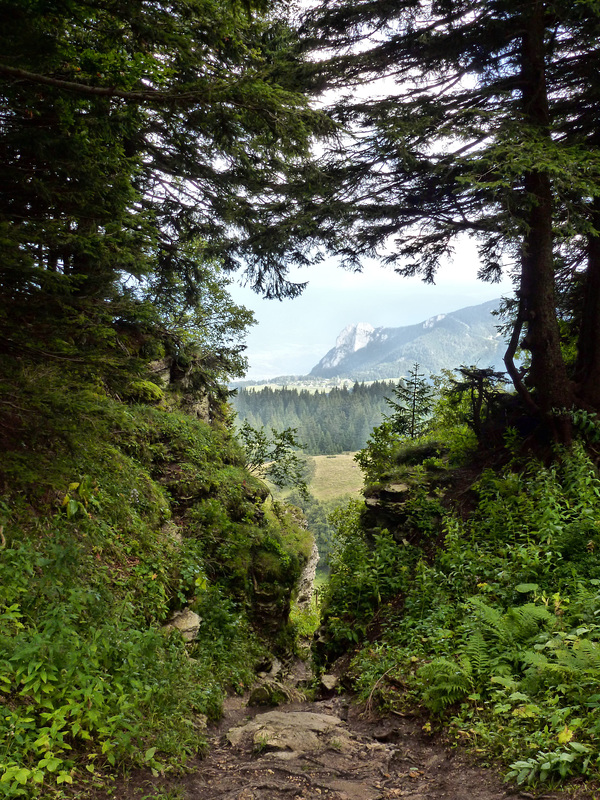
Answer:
[{"left": 232, "top": 381, "right": 391, "bottom": 455}]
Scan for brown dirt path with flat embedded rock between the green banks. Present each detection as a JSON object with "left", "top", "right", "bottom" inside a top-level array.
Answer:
[{"left": 97, "top": 664, "right": 600, "bottom": 800}]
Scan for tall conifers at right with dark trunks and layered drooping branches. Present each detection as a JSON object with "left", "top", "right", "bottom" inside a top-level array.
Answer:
[{"left": 240, "top": 0, "right": 600, "bottom": 438}]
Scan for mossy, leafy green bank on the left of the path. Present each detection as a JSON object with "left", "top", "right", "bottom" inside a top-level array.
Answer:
[{"left": 0, "top": 368, "right": 312, "bottom": 798}]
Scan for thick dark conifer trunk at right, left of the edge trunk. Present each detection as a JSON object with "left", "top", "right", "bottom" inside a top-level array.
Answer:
[{"left": 520, "top": 0, "right": 574, "bottom": 442}]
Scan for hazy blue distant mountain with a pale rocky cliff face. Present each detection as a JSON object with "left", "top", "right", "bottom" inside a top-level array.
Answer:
[{"left": 310, "top": 300, "right": 506, "bottom": 381}]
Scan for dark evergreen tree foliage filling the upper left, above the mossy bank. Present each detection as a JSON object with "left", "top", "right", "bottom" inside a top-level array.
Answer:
[{"left": 0, "top": 0, "right": 325, "bottom": 388}]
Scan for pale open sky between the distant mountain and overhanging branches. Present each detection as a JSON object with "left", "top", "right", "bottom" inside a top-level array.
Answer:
[{"left": 229, "top": 239, "right": 512, "bottom": 380}]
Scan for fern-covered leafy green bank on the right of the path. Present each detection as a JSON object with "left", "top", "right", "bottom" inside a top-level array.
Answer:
[{"left": 315, "top": 388, "right": 600, "bottom": 786}]
